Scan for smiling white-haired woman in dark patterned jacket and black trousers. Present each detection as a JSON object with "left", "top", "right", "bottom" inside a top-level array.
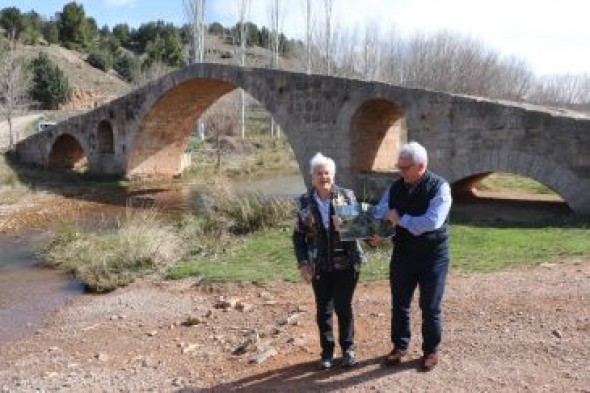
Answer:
[{"left": 293, "top": 153, "right": 364, "bottom": 369}]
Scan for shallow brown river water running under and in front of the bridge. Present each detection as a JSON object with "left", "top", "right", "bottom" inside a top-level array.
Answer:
[{"left": 0, "top": 175, "right": 305, "bottom": 345}]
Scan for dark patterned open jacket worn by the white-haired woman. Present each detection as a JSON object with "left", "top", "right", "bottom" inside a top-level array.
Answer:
[{"left": 293, "top": 185, "right": 365, "bottom": 274}]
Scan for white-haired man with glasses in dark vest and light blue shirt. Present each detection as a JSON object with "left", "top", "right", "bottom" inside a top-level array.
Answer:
[{"left": 373, "top": 142, "right": 452, "bottom": 371}]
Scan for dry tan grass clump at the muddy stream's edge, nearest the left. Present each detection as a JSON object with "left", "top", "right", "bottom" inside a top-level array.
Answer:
[{"left": 41, "top": 211, "right": 185, "bottom": 292}]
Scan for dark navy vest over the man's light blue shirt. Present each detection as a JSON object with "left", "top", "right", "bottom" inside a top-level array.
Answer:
[{"left": 389, "top": 171, "right": 449, "bottom": 251}]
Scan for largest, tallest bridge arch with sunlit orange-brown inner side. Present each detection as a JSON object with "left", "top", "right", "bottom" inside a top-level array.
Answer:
[{"left": 126, "top": 65, "right": 289, "bottom": 176}]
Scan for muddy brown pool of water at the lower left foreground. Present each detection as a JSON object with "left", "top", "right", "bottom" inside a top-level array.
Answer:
[{"left": 0, "top": 236, "right": 83, "bottom": 345}]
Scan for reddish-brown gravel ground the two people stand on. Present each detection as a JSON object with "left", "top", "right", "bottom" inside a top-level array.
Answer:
[{"left": 0, "top": 258, "right": 590, "bottom": 392}]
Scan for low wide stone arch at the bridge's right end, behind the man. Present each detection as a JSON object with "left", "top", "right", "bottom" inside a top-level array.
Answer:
[{"left": 438, "top": 150, "right": 580, "bottom": 210}]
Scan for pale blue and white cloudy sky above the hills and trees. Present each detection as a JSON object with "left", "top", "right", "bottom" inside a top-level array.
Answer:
[{"left": 5, "top": 0, "right": 590, "bottom": 76}]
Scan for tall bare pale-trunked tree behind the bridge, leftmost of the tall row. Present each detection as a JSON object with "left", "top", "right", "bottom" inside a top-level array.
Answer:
[{"left": 184, "top": 0, "right": 205, "bottom": 140}]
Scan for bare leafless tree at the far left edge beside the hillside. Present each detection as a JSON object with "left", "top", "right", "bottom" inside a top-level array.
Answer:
[{"left": 0, "top": 38, "right": 31, "bottom": 150}]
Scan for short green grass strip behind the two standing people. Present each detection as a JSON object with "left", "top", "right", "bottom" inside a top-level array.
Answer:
[{"left": 168, "top": 220, "right": 590, "bottom": 281}]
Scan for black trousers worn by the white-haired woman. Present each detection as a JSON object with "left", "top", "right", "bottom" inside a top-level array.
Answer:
[{"left": 313, "top": 267, "right": 358, "bottom": 358}]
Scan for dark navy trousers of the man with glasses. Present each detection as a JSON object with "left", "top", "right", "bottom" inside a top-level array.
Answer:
[{"left": 389, "top": 239, "right": 449, "bottom": 354}]
